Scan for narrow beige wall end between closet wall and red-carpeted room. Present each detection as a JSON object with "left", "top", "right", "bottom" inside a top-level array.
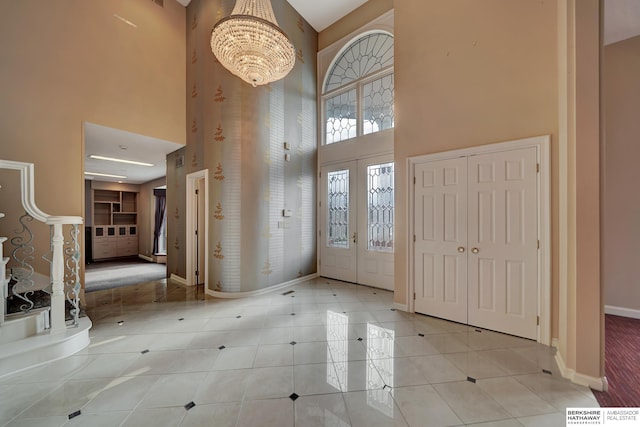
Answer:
[{"left": 572, "top": 0, "right": 604, "bottom": 384}]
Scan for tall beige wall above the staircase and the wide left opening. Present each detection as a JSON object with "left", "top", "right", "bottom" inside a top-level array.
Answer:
[{"left": 0, "top": 0, "right": 186, "bottom": 278}]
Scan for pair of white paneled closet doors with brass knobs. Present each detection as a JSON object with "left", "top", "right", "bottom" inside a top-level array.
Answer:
[{"left": 414, "top": 147, "right": 539, "bottom": 339}]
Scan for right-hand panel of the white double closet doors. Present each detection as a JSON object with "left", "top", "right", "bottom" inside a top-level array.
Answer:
[{"left": 468, "top": 148, "right": 538, "bottom": 339}]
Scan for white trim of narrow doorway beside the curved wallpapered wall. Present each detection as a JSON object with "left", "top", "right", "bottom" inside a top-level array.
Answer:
[{"left": 185, "top": 169, "right": 209, "bottom": 289}]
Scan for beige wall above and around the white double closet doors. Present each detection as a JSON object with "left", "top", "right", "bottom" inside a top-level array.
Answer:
[{"left": 395, "top": 0, "right": 558, "bottom": 314}]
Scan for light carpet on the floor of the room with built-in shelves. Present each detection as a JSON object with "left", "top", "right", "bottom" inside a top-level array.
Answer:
[{"left": 84, "top": 260, "right": 167, "bottom": 292}]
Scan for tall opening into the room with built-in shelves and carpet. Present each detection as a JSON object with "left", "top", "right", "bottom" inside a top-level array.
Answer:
[{"left": 83, "top": 122, "right": 183, "bottom": 292}]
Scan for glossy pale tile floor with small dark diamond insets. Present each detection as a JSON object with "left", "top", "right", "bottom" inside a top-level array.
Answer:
[{"left": 0, "top": 279, "right": 598, "bottom": 427}]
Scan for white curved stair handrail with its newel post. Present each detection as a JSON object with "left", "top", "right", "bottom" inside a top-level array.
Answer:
[{"left": 0, "top": 159, "right": 83, "bottom": 332}]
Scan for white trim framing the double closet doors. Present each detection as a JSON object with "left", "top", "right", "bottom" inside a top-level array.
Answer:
[{"left": 406, "top": 135, "right": 551, "bottom": 345}]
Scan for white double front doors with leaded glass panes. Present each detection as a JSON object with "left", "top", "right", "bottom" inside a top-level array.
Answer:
[{"left": 320, "top": 156, "right": 394, "bottom": 290}]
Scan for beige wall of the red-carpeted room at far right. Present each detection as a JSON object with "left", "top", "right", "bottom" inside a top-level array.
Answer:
[{"left": 603, "top": 37, "right": 640, "bottom": 310}]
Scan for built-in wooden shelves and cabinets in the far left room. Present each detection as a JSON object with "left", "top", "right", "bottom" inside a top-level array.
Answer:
[{"left": 91, "top": 189, "right": 138, "bottom": 260}]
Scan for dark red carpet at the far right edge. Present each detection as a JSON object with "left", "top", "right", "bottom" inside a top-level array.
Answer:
[{"left": 593, "top": 314, "right": 640, "bottom": 407}]
